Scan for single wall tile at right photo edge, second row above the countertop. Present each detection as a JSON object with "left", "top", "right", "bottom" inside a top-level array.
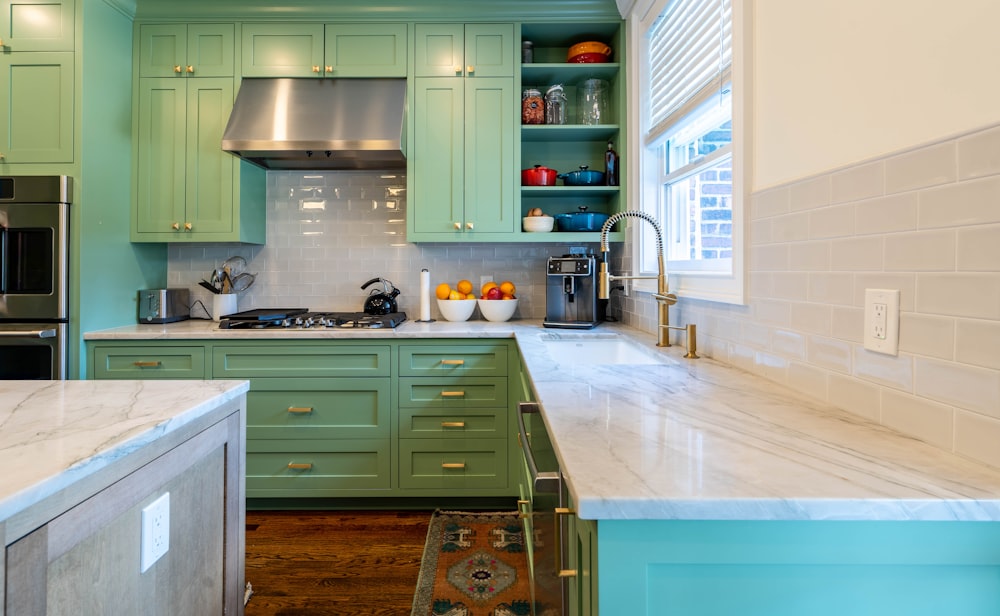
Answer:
[{"left": 914, "top": 357, "right": 1000, "bottom": 419}]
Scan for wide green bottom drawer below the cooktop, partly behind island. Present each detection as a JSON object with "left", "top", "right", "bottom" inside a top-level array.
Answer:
[{"left": 246, "top": 439, "right": 391, "bottom": 496}]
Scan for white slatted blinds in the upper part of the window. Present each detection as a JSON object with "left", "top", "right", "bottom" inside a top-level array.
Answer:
[{"left": 647, "top": 0, "right": 733, "bottom": 138}]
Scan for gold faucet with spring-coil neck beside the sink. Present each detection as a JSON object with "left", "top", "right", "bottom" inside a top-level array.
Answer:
[{"left": 597, "top": 210, "right": 698, "bottom": 359}]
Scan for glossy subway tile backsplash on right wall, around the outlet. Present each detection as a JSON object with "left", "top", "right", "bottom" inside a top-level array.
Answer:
[{"left": 624, "top": 127, "right": 1000, "bottom": 466}]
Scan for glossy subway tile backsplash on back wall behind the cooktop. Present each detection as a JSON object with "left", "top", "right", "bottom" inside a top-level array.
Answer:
[{"left": 167, "top": 171, "right": 596, "bottom": 319}]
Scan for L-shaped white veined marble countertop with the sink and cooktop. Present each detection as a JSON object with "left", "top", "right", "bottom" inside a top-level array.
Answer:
[{"left": 85, "top": 321, "right": 1000, "bottom": 521}]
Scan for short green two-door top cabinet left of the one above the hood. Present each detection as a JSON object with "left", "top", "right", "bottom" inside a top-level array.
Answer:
[{"left": 139, "top": 24, "right": 235, "bottom": 77}]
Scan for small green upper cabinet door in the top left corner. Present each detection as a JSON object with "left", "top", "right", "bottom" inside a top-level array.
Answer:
[{"left": 0, "top": 0, "right": 76, "bottom": 52}]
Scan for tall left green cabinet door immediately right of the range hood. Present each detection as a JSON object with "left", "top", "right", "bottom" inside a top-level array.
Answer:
[{"left": 407, "top": 77, "right": 465, "bottom": 236}]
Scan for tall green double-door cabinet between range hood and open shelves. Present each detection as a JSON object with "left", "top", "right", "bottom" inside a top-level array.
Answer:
[{"left": 407, "top": 77, "right": 515, "bottom": 242}]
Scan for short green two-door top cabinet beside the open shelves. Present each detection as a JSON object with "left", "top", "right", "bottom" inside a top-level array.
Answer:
[{"left": 413, "top": 24, "right": 516, "bottom": 77}]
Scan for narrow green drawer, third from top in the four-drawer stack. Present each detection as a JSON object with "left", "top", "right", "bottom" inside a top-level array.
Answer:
[{"left": 399, "top": 407, "right": 508, "bottom": 439}]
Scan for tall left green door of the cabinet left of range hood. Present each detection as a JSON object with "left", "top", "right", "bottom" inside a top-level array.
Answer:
[{"left": 133, "top": 78, "right": 187, "bottom": 232}]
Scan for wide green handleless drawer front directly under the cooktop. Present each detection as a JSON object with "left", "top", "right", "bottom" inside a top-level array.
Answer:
[{"left": 212, "top": 343, "right": 390, "bottom": 379}]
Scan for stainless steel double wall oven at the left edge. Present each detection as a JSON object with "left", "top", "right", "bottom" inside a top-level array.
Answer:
[{"left": 0, "top": 175, "right": 73, "bottom": 380}]
